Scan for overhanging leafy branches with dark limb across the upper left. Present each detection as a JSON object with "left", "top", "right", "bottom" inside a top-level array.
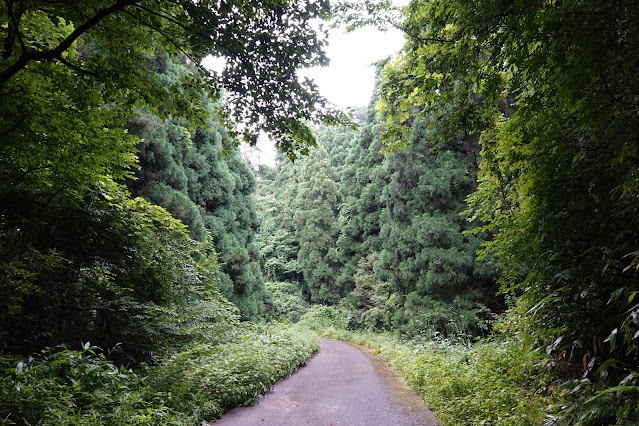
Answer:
[{"left": 0, "top": 0, "right": 345, "bottom": 161}]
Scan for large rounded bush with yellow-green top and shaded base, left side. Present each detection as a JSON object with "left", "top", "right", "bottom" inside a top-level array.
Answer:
[{"left": 0, "top": 179, "right": 234, "bottom": 363}]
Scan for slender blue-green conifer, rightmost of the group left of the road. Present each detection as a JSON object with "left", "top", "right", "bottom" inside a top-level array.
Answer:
[{"left": 186, "top": 129, "right": 268, "bottom": 317}]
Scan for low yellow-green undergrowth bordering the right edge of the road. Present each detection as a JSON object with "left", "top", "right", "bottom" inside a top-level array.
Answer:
[{"left": 319, "top": 327, "right": 549, "bottom": 426}]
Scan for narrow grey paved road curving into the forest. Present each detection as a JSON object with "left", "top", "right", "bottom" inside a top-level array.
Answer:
[{"left": 214, "top": 340, "right": 438, "bottom": 426}]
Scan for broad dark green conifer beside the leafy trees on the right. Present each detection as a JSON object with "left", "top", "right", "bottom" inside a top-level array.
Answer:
[{"left": 375, "top": 122, "right": 500, "bottom": 334}]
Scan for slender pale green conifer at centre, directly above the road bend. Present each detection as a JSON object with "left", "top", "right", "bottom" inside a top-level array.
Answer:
[{"left": 293, "top": 147, "right": 346, "bottom": 303}]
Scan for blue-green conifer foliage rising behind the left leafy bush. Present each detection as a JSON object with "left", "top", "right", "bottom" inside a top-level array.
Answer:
[{"left": 128, "top": 55, "right": 268, "bottom": 317}]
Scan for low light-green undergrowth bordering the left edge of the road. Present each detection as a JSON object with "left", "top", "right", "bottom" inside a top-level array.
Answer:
[{"left": 149, "top": 323, "right": 319, "bottom": 419}]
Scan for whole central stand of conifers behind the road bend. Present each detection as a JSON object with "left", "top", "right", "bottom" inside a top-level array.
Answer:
[{"left": 262, "top": 85, "right": 505, "bottom": 336}]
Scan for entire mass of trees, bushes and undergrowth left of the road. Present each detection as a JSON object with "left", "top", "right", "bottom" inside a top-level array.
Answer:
[{"left": 0, "top": 0, "right": 346, "bottom": 424}]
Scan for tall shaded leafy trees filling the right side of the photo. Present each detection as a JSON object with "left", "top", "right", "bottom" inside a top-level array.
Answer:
[{"left": 370, "top": 0, "right": 639, "bottom": 424}]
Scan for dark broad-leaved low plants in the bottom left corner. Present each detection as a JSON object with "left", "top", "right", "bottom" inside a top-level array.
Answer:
[{"left": 0, "top": 343, "right": 178, "bottom": 424}]
